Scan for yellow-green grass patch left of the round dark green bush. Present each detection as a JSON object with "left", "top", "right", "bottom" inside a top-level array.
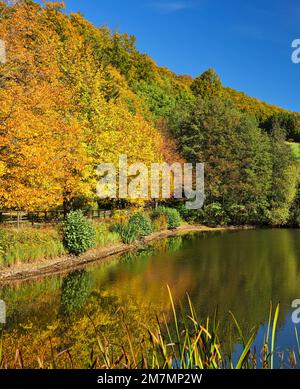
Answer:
[{"left": 0, "top": 227, "right": 65, "bottom": 266}]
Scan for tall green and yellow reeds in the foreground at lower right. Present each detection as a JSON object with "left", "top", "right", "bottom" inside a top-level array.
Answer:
[{"left": 92, "top": 288, "right": 290, "bottom": 369}]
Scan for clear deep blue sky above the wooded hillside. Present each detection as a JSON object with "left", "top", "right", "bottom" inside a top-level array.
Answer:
[{"left": 38, "top": 0, "right": 300, "bottom": 111}]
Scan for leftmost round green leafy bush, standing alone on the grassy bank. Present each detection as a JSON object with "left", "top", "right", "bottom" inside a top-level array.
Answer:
[{"left": 63, "top": 211, "right": 95, "bottom": 255}]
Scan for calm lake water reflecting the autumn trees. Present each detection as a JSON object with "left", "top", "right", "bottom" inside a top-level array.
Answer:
[{"left": 0, "top": 229, "right": 300, "bottom": 367}]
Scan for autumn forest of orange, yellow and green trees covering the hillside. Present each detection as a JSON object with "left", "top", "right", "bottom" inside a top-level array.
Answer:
[{"left": 0, "top": 0, "right": 300, "bottom": 226}]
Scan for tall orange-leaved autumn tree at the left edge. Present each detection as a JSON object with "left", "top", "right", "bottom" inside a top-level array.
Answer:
[{"left": 0, "top": 1, "right": 90, "bottom": 210}]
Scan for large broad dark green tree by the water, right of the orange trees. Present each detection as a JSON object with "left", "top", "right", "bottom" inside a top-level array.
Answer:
[{"left": 175, "top": 99, "right": 272, "bottom": 222}]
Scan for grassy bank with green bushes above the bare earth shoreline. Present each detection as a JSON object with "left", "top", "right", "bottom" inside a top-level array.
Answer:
[{"left": 0, "top": 207, "right": 181, "bottom": 267}]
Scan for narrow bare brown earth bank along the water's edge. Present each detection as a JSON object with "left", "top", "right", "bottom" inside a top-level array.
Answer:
[{"left": 0, "top": 225, "right": 252, "bottom": 286}]
